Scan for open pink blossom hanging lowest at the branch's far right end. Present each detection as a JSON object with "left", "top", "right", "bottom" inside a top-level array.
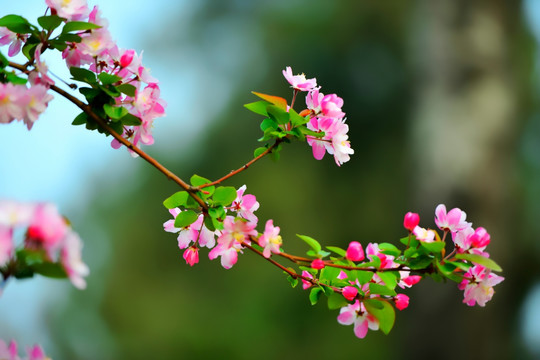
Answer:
[{"left": 458, "top": 265, "right": 504, "bottom": 307}]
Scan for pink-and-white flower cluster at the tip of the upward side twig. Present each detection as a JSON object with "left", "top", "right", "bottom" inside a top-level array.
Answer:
[{"left": 283, "top": 66, "right": 354, "bottom": 166}]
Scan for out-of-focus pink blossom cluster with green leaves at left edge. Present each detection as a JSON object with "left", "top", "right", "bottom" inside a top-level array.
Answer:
[{"left": 0, "top": 200, "right": 89, "bottom": 289}]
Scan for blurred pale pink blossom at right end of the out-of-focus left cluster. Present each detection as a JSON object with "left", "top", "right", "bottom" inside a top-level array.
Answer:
[{"left": 60, "top": 230, "right": 90, "bottom": 290}]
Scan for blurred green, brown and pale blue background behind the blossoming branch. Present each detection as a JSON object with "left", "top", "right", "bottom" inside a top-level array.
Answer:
[{"left": 0, "top": 0, "right": 540, "bottom": 359}]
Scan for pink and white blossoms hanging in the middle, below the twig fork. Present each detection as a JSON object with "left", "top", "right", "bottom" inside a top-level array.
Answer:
[{"left": 163, "top": 185, "right": 282, "bottom": 269}]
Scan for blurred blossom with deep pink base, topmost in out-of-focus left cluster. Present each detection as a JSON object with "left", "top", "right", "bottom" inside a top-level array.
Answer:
[{"left": 27, "top": 203, "right": 68, "bottom": 258}]
